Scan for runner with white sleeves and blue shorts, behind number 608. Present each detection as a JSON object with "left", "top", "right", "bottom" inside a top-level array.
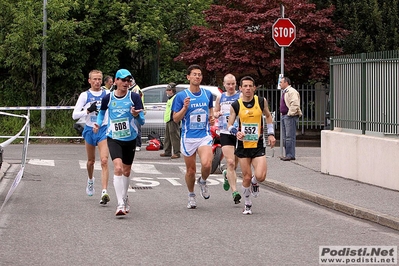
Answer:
[{"left": 72, "top": 70, "right": 110, "bottom": 204}]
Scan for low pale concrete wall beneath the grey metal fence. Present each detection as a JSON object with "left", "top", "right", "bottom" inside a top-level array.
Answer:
[{"left": 321, "top": 128, "right": 399, "bottom": 190}]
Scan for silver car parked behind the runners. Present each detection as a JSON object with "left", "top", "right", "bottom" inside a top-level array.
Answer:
[{"left": 141, "top": 84, "right": 221, "bottom": 139}]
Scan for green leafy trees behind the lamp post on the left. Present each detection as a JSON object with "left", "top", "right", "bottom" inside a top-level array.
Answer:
[{"left": 0, "top": 0, "right": 211, "bottom": 106}]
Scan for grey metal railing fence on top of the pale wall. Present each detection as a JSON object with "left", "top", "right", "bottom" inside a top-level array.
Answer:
[{"left": 330, "top": 50, "right": 399, "bottom": 135}]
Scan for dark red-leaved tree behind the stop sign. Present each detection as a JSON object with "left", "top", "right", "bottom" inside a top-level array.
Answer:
[{"left": 175, "top": 0, "right": 346, "bottom": 84}]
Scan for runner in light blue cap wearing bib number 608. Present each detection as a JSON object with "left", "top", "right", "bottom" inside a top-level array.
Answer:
[{"left": 93, "top": 69, "right": 145, "bottom": 216}]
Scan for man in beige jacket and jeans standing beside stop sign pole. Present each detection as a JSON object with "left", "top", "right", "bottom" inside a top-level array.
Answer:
[{"left": 280, "top": 77, "right": 302, "bottom": 161}]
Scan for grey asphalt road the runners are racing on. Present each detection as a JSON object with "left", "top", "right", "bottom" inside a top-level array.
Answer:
[{"left": 0, "top": 144, "right": 399, "bottom": 265}]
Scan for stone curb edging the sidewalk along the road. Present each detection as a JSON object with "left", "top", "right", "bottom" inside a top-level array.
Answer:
[{"left": 262, "top": 179, "right": 399, "bottom": 231}]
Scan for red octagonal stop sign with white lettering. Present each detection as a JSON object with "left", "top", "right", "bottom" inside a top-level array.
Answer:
[{"left": 272, "top": 18, "right": 296, "bottom": 47}]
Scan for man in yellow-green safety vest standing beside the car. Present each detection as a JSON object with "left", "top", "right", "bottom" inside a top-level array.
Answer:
[{"left": 160, "top": 83, "right": 180, "bottom": 159}]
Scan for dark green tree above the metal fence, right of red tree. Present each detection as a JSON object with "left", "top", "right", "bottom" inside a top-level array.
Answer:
[{"left": 311, "top": 0, "right": 399, "bottom": 54}]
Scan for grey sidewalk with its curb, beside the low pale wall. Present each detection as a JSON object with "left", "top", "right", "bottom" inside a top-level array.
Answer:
[{"left": 263, "top": 147, "right": 399, "bottom": 230}]
